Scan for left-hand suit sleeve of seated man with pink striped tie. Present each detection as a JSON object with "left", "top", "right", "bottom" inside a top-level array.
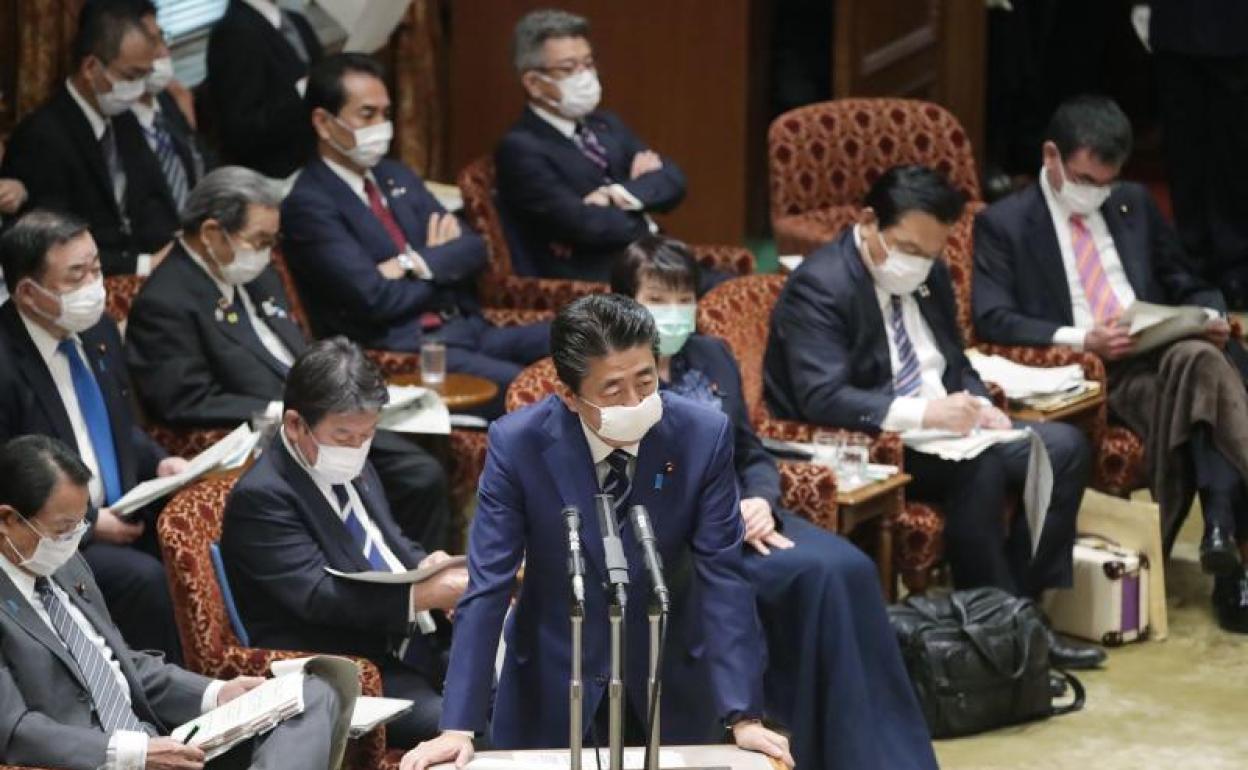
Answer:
[{"left": 971, "top": 210, "right": 1058, "bottom": 346}]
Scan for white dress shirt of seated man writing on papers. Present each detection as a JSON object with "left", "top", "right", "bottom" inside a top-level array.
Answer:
[{"left": 854, "top": 225, "right": 948, "bottom": 431}]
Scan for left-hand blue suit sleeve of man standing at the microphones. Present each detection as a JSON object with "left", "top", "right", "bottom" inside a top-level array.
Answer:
[{"left": 441, "top": 423, "right": 524, "bottom": 733}]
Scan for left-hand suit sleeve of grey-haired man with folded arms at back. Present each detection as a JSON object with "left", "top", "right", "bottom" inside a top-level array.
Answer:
[{"left": 495, "top": 136, "right": 648, "bottom": 250}]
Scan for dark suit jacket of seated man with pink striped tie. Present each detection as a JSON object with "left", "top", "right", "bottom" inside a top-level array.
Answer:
[{"left": 972, "top": 182, "right": 1227, "bottom": 346}]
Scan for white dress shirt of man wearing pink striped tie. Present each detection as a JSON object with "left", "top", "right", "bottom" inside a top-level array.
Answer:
[{"left": 1040, "top": 166, "right": 1136, "bottom": 349}]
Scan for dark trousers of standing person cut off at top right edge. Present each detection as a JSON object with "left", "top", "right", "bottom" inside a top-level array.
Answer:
[{"left": 1153, "top": 51, "right": 1248, "bottom": 303}]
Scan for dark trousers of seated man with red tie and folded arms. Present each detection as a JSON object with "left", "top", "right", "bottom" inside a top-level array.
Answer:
[{"left": 441, "top": 316, "right": 550, "bottom": 418}]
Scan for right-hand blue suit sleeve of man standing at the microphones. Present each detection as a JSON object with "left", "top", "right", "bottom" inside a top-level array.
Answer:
[{"left": 690, "top": 419, "right": 765, "bottom": 720}]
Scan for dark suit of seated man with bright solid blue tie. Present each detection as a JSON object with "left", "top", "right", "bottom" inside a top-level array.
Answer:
[{"left": 0, "top": 300, "right": 181, "bottom": 659}]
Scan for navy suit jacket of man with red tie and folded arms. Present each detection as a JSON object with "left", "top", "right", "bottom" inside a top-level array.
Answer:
[{"left": 282, "top": 158, "right": 485, "bottom": 352}]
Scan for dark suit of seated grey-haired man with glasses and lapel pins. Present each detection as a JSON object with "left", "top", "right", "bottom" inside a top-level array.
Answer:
[{"left": 126, "top": 243, "right": 451, "bottom": 547}]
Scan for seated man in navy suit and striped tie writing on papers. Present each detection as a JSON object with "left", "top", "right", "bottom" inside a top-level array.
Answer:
[{"left": 764, "top": 166, "right": 1104, "bottom": 668}]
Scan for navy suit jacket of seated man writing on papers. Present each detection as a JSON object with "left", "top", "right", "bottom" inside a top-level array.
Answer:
[{"left": 763, "top": 228, "right": 987, "bottom": 433}]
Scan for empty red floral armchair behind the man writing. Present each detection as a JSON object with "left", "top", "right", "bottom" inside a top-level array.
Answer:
[{"left": 768, "top": 99, "right": 981, "bottom": 255}]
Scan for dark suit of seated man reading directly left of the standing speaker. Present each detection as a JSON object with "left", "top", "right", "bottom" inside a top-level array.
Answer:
[{"left": 221, "top": 436, "right": 442, "bottom": 748}]
